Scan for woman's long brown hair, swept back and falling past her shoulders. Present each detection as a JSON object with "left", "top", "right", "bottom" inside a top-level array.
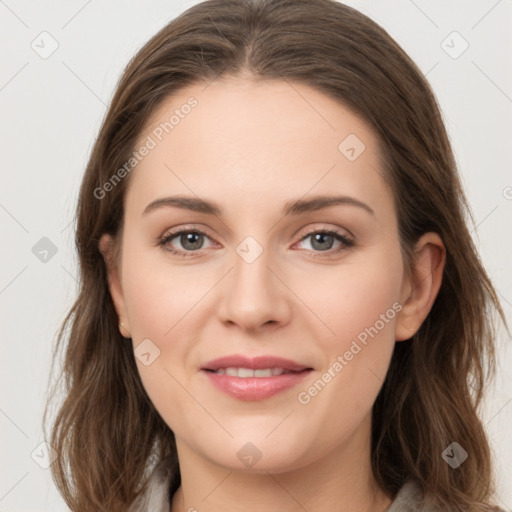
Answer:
[{"left": 43, "top": 0, "right": 505, "bottom": 512}]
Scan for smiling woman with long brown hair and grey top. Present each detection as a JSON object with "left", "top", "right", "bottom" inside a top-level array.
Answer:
[{"left": 44, "top": 0, "right": 503, "bottom": 512}]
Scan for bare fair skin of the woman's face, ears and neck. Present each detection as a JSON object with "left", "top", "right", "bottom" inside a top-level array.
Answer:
[{"left": 100, "top": 77, "right": 445, "bottom": 512}]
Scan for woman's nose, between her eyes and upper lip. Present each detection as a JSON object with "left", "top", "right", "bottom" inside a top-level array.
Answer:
[{"left": 218, "top": 239, "right": 293, "bottom": 332}]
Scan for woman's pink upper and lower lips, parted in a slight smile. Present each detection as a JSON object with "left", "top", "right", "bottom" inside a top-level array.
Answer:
[{"left": 201, "top": 355, "right": 312, "bottom": 400}]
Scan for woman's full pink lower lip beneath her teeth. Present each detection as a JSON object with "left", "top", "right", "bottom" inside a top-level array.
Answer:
[{"left": 201, "top": 370, "right": 312, "bottom": 400}]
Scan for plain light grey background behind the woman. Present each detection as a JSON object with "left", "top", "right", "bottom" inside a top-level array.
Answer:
[{"left": 0, "top": 0, "right": 512, "bottom": 512}]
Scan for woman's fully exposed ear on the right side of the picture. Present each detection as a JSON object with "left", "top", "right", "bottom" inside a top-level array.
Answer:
[{"left": 395, "top": 233, "right": 446, "bottom": 341}]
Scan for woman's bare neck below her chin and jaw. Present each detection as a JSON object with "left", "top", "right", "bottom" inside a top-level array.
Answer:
[{"left": 171, "top": 416, "right": 392, "bottom": 512}]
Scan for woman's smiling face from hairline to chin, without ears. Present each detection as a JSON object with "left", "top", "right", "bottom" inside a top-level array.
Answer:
[{"left": 106, "top": 78, "right": 414, "bottom": 472}]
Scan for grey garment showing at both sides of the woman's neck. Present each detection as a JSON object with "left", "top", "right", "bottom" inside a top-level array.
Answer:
[{"left": 128, "top": 460, "right": 433, "bottom": 512}]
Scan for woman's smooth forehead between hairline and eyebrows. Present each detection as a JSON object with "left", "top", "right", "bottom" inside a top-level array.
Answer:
[{"left": 127, "top": 78, "right": 392, "bottom": 221}]
